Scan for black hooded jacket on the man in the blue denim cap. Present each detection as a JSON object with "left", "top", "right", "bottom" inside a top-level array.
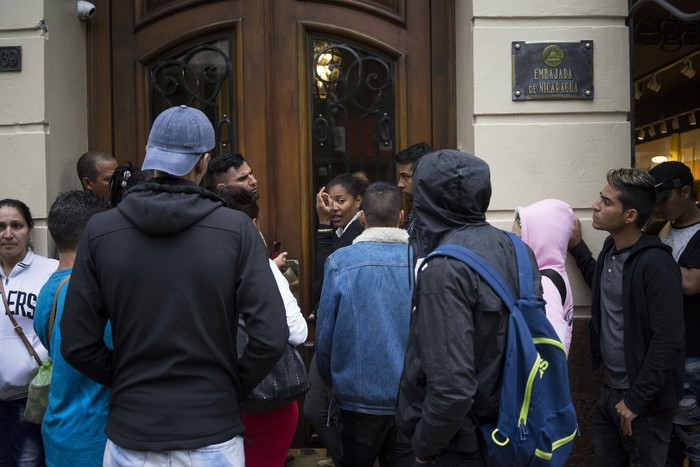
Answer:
[{"left": 61, "top": 178, "right": 289, "bottom": 451}]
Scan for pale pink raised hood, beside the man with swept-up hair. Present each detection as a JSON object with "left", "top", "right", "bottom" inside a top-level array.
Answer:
[{"left": 516, "top": 199, "right": 574, "bottom": 272}]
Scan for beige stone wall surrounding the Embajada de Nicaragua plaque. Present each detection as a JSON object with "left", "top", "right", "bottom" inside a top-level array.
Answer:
[{"left": 456, "top": 0, "right": 631, "bottom": 314}]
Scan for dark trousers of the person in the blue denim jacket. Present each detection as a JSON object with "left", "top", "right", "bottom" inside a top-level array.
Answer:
[{"left": 336, "top": 410, "right": 415, "bottom": 467}]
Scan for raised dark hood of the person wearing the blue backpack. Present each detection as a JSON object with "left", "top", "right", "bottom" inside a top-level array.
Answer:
[{"left": 412, "top": 149, "right": 491, "bottom": 257}]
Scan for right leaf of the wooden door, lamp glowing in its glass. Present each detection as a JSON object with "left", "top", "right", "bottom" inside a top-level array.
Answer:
[{"left": 270, "top": 0, "right": 454, "bottom": 318}]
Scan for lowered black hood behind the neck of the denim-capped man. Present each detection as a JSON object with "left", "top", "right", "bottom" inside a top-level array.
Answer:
[{"left": 117, "top": 177, "right": 223, "bottom": 235}]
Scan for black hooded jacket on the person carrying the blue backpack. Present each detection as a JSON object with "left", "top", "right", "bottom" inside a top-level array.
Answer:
[{"left": 397, "top": 151, "right": 542, "bottom": 459}]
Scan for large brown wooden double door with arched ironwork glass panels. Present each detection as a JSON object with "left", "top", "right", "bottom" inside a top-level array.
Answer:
[{"left": 87, "top": 0, "right": 456, "bottom": 446}]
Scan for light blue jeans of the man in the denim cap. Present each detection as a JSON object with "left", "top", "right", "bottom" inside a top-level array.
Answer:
[{"left": 102, "top": 436, "right": 245, "bottom": 467}]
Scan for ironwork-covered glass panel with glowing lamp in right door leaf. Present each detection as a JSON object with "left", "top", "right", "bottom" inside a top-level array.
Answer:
[{"left": 309, "top": 36, "right": 396, "bottom": 192}]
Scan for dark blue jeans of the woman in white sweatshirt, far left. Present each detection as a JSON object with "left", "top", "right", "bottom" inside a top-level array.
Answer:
[{"left": 0, "top": 398, "right": 44, "bottom": 467}]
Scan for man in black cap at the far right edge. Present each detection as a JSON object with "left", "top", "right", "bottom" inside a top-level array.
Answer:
[{"left": 649, "top": 161, "right": 700, "bottom": 467}]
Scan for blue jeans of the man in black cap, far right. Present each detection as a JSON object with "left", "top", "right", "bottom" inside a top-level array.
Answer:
[{"left": 666, "top": 357, "right": 700, "bottom": 467}]
